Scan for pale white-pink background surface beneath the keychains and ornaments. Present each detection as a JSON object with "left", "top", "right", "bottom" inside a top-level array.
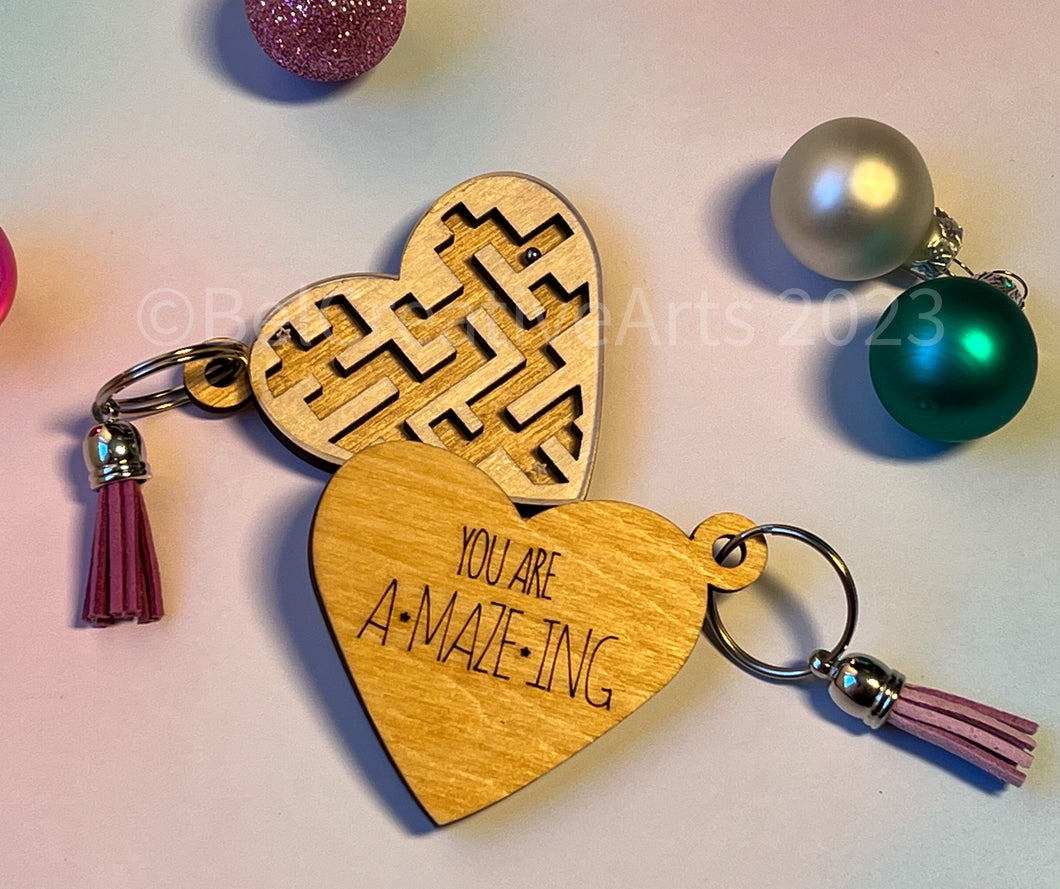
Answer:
[{"left": 0, "top": 0, "right": 1060, "bottom": 889}]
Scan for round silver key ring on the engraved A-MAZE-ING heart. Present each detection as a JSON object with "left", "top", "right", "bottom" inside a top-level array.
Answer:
[{"left": 707, "top": 524, "right": 858, "bottom": 679}]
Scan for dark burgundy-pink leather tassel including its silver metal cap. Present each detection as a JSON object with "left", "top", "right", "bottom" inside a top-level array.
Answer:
[{"left": 82, "top": 422, "right": 163, "bottom": 626}]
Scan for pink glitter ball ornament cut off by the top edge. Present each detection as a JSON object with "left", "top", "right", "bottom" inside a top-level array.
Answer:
[{"left": 245, "top": 0, "right": 405, "bottom": 82}]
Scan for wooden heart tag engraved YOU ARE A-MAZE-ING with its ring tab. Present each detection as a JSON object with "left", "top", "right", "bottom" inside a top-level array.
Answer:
[{"left": 311, "top": 443, "right": 765, "bottom": 824}]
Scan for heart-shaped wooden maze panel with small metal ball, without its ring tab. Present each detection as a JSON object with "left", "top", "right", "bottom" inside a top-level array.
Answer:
[{"left": 243, "top": 174, "right": 602, "bottom": 504}]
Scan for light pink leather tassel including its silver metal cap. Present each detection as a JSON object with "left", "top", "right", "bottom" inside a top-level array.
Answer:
[{"left": 811, "top": 652, "right": 1038, "bottom": 787}]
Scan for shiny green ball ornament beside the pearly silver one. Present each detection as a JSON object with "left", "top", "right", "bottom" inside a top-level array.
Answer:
[{"left": 869, "top": 277, "right": 1038, "bottom": 442}]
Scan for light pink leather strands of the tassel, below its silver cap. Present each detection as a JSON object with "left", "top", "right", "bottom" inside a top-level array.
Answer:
[{"left": 887, "top": 683, "right": 1038, "bottom": 787}]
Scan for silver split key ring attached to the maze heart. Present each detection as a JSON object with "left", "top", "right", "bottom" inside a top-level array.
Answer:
[{"left": 92, "top": 338, "right": 250, "bottom": 423}]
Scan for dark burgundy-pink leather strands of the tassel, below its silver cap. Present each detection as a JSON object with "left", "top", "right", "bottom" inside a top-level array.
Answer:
[{"left": 82, "top": 479, "right": 163, "bottom": 626}]
